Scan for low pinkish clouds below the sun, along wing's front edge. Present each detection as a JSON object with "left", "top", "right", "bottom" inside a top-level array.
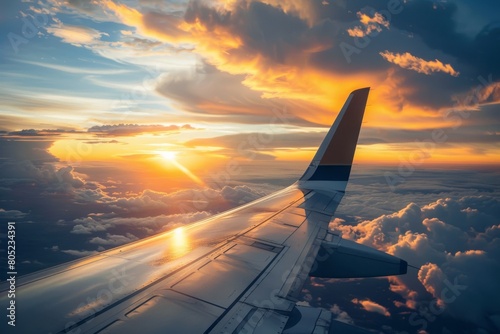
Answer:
[{"left": 65, "top": 186, "right": 265, "bottom": 239}]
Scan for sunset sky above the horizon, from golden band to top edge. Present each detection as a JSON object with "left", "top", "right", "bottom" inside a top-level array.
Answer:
[{"left": 0, "top": 0, "right": 500, "bottom": 169}]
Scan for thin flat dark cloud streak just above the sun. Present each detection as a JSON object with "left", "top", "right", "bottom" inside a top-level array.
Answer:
[{"left": 87, "top": 124, "right": 194, "bottom": 137}]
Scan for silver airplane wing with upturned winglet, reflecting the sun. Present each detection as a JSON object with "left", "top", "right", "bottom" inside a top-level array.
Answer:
[{"left": 0, "top": 88, "right": 407, "bottom": 334}]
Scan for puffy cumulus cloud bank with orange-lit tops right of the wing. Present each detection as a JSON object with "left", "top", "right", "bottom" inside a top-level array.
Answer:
[{"left": 331, "top": 195, "right": 500, "bottom": 330}]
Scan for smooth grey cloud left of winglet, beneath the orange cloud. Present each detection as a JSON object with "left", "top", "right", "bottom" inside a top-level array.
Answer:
[{"left": 156, "top": 63, "right": 314, "bottom": 126}]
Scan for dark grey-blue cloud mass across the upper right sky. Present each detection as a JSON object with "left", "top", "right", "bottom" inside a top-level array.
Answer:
[{"left": 161, "top": 1, "right": 500, "bottom": 112}]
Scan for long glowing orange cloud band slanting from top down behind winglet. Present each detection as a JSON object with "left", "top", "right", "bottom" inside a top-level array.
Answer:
[{"left": 97, "top": 0, "right": 460, "bottom": 133}]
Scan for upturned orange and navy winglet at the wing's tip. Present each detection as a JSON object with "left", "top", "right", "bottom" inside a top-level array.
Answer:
[{"left": 299, "top": 87, "right": 370, "bottom": 191}]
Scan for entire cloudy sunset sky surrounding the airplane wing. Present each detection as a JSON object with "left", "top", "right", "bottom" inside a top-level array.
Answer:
[{"left": 0, "top": 0, "right": 500, "bottom": 333}]
